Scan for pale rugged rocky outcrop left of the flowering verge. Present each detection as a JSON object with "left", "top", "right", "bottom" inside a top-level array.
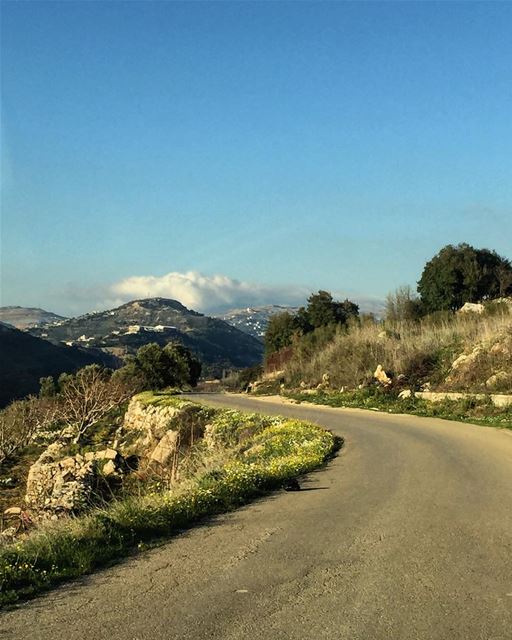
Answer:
[{"left": 21, "top": 398, "right": 206, "bottom": 518}]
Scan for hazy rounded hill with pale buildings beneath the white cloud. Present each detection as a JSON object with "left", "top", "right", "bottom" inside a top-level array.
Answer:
[{"left": 29, "top": 298, "right": 263, "bottom": 375}]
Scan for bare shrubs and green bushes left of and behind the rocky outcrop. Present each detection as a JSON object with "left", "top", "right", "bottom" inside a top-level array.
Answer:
[{"left": 0, "top": 343, "right": 206, "bottom": 576}]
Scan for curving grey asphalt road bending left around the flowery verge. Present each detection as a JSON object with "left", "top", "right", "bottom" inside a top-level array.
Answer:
[{"left": 0, "top": 395, "right": 512, "bottom": 640}]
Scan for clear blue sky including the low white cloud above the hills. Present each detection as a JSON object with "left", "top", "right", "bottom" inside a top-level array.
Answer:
[{"left": 0, "top": 1, "right": 512, "bottom": 314}]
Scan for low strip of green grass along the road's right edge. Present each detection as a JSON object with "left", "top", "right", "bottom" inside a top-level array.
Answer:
[{"left": 283, "top": 387, "right": 512, "bottom": 429}]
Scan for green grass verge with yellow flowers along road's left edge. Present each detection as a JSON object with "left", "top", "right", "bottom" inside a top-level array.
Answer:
[{"left": 0, "top": 394, "right": 340, "bottom": 605}]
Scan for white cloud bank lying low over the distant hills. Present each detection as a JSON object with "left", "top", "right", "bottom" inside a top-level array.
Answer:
[{"left": 52, "top": 271, "right": 383, "bottom": 315}]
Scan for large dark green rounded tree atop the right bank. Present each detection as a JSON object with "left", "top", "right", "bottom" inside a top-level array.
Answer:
[{"left": 418, "top": 243, "right": 512, "bottom": 313}]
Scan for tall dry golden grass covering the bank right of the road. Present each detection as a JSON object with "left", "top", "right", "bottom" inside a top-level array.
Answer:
[{"left": 286, "top": 311, "right": 512, "bottom": 393}]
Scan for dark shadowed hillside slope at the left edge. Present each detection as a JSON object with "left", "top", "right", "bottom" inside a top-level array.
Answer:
[{"left": 0, "top": 323, "right": 116, "bottom": 407}]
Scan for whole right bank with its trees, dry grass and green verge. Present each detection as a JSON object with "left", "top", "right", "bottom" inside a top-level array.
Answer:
[{"left": 240, "top": 244, "right": 512, "bottom": 426}]
